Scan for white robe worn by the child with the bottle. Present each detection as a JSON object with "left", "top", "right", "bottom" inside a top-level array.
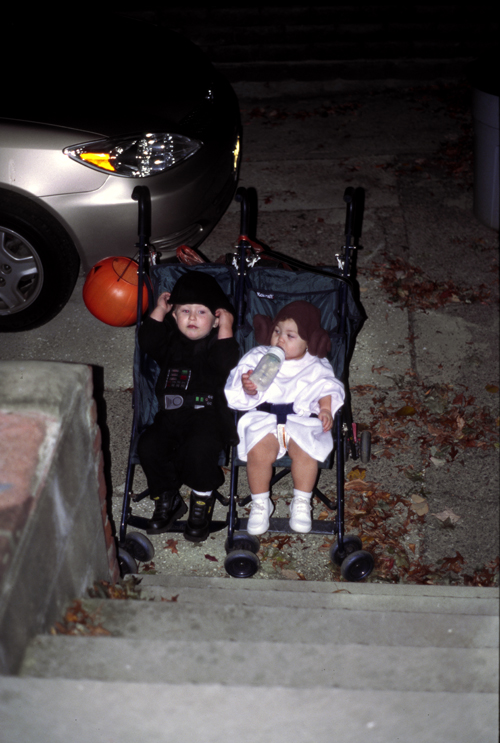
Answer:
[{"left": 225, "top": 346, "right": 345, "bottom": 462}]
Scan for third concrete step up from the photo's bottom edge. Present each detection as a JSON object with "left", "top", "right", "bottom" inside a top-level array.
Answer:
[{"left": 21, "top": 599, "right": 498, "bottom": 648}]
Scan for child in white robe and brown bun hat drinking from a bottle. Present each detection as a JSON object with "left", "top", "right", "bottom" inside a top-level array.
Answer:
[{"left": 225, "top": 301, "right": 345, "bottom": 535}]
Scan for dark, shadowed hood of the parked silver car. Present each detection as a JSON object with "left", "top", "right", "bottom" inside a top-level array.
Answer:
[{"left": 0, "top": 16, "right": 218, "bottom": 136}]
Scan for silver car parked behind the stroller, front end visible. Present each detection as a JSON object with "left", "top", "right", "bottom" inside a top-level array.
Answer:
[{"left": 0, "top": 10, "right": 241, "bottom": 331}]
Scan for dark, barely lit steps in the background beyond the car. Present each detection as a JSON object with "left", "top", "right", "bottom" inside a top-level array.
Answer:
[{"left": 125, "top": 2, "right": 498, "bottom": 82}]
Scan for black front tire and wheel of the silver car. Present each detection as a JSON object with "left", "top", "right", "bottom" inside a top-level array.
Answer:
[{"left": 0, "top": 191, "right": 80, "bottom": 332}]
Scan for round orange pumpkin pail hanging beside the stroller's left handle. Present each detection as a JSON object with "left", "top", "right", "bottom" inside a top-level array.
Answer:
[{"left": 83, "top": 256, "right": 148, "bottom": 328}]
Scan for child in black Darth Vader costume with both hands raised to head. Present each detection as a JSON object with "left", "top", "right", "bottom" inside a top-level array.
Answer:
[{"left": 138, "top": 271, "right": 238, "bottom": 542}]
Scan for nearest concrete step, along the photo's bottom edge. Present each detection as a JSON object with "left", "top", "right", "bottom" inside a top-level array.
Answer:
[{"left": 0, "top": 677, "right": 498, "bottom": 743}]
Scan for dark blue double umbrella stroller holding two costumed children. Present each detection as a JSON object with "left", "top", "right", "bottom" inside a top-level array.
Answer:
[{"left": 118, "top": 186, "right": 374, "bottom": 581}]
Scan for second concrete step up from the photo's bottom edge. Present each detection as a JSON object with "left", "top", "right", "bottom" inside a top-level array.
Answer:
[{"left": 18, "top": 636, "right": 498, "bottom": 693}]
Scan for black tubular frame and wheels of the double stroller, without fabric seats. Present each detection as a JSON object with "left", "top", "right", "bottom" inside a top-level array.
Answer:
[{"left": 118, "top": 186, "right": 374, "bottom": 581}]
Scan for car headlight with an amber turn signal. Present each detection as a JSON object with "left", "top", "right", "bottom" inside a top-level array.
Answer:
[{"left": 63, "top": 133, "right": 202, "bottom": 178}]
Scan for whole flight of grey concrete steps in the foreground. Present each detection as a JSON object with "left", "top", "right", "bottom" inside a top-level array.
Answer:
[{"left": 0, "top": 575, "right": 498, "bottom": 743}]
